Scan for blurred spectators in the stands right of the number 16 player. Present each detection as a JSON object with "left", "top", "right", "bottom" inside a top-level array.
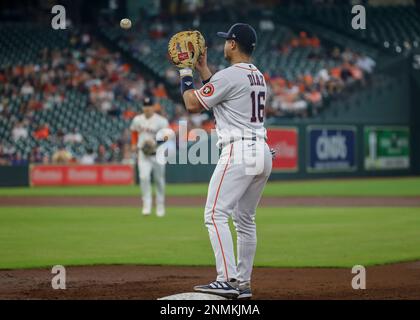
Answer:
[{"left": 265, "top": 37, "right": 376, "bottom": 117}]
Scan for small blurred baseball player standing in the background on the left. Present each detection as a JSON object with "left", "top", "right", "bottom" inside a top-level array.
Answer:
[{"left": 130, "top": 97, "right": 169, "bottom": 217}]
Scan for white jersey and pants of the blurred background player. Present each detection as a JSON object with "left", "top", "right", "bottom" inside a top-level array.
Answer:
[{"left": 130, "top": 113, "right": 169, "bottom": 215}]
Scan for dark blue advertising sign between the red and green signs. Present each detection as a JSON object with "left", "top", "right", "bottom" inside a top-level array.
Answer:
[{"left": 306, "top": 126, "right": 357, "bottom": 172}]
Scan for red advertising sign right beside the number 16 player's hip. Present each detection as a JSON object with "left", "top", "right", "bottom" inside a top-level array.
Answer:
[{"left": 267, "top": 128, "right": 298, "bottom": 172}]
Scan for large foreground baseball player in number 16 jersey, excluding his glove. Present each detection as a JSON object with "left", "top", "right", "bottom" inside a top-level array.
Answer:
[{"left": 176, "top": 23, "right": 272, "bottom": 299}]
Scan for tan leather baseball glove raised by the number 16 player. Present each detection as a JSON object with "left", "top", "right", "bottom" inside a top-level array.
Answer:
[{"left": 168, "top": 31, "right": 206, "bottom": 69}]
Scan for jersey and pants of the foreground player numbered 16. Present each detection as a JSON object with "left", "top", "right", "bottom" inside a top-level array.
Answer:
[{"left": 194, "top": 63, "right": 272, "bottom": 281}]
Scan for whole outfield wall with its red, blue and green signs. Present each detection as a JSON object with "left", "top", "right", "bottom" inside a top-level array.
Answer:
[{"left": 0, "top": 123, "right": 418, "bottom": 186}]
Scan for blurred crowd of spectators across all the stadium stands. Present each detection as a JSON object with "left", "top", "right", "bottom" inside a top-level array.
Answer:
[{"left": 0, "top": 15, "right": 376, "bottom": 165}]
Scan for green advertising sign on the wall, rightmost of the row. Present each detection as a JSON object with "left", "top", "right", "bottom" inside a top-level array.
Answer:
[{"left": 364, "top": 126, "right": 410, "bottom": 170}]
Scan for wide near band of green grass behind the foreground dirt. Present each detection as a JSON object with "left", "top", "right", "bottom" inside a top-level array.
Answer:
[{"left": 0, "top": 207, "right": 420, "bottom": 269}]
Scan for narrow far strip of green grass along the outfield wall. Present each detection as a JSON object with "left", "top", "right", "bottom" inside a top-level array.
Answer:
[{"left": 0, "top": 178, "right": 420, "bottom": 196}]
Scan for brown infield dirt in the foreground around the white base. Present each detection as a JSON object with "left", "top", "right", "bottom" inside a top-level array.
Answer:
[{"left": 0, "top": 261, "right": 420, "bottom": 300}]
